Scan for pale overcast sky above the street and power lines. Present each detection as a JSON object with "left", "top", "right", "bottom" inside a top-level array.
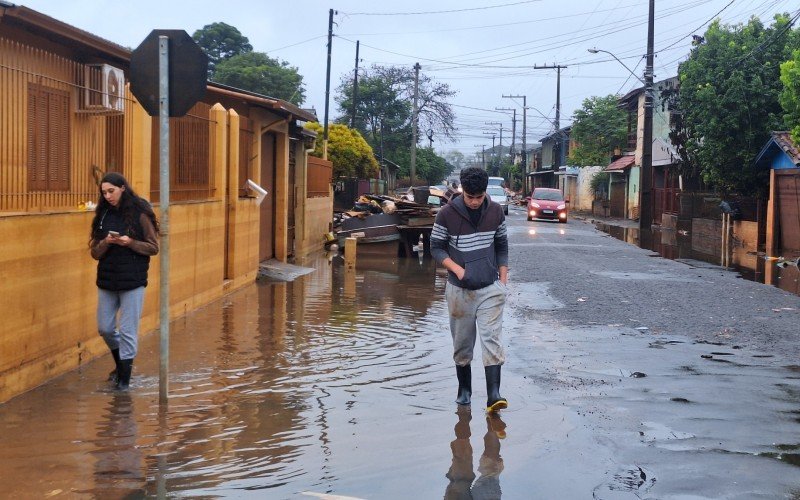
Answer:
[{"left": 18, "top": 0, "right": 798, "bottom": 155}]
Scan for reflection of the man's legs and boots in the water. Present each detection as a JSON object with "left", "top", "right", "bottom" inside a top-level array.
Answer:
[{"left": 444, "top": 407, "right": 506, "bottom": 500}]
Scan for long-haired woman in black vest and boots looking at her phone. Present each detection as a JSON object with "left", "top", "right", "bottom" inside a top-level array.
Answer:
[{"left": 89, "top": 172, "right": 158, "bottom": 390}]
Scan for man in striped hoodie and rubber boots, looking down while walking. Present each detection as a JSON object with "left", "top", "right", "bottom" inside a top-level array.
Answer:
[{"left": 431, "top": 167, "right": 508, "bottom": 412}]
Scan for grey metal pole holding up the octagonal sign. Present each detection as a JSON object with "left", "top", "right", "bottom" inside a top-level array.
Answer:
[{"left": 158, "top": 36, "right": 169, "bottom": 404}]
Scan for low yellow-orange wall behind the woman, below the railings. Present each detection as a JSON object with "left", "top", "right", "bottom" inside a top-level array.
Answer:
[{"left": 0, "top": 201, "right": 244, "bottom": 402}]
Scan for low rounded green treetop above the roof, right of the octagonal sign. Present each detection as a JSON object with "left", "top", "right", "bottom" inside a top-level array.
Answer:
[{"left": 214, "top": 52, "right": 305, "bottom": 105}]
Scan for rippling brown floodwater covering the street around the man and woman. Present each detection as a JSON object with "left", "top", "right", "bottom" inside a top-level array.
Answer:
[{"left": 0, "top": 214, "right": 800, "bottom": 499}]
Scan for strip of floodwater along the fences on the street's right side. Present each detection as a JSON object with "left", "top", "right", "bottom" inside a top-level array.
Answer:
[{"left": 595, "top": 222, "right": 800, "bottom": 295}]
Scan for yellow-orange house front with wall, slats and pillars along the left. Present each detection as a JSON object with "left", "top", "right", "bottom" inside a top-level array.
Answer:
[{"left": 0, "top": 36, "right": 332, "bottom": 402}]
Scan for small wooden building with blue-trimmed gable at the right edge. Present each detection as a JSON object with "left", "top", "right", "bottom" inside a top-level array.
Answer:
[{"left": 755, "top": 132, "right": 800, "bottom": 256}]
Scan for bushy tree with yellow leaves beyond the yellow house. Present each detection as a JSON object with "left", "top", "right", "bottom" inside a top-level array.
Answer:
[{"left": 306, "top": 122, "right": 380, "bottom": 179}]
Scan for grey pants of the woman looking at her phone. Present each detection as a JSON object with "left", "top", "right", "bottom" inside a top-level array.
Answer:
[{"left": 97, "top": 286, "right": 144, "bottom": 359}]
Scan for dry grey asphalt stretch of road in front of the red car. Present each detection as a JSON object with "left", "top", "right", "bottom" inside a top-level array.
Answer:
[{"left": 508, "top": 205, "right": 800, "bottom": 360}]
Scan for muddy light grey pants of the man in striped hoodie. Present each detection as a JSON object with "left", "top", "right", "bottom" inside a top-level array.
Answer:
[{"left": 445, "top": 281, "right": 508, "bottom": 366}]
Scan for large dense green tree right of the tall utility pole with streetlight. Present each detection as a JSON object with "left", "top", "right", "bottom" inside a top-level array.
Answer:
[{"left": 674, "top": 15, "right": 798, "bottom": 195}]
